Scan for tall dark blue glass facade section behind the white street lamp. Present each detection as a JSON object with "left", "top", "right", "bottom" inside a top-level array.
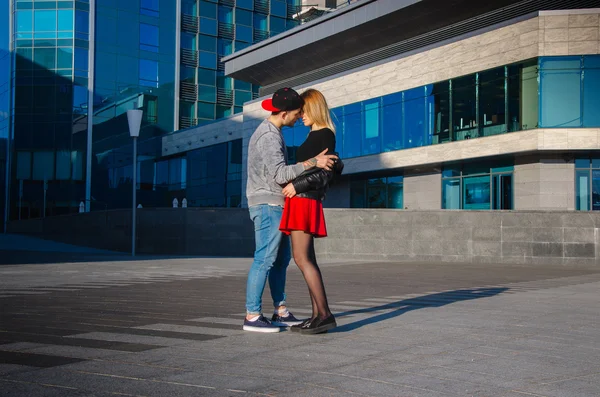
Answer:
[{"left": 91, "top": 0, "right": 177, "bottom": 210}]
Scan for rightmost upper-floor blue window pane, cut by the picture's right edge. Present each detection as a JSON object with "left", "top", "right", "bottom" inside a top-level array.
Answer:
[{"left": 583, "top": 55, "right": 600, "bottom": 127}]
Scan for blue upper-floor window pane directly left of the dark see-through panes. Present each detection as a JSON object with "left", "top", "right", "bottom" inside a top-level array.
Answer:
[{"left": 403, "top": 87, "right": 425, "bottom": 149}]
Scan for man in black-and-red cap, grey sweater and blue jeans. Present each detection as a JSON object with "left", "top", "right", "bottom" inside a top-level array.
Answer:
[{"left": 243, "top": 88, "right": 336, "bottom": 332}]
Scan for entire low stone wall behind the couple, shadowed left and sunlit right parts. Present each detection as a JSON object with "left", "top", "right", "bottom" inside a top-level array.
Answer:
[{"left": 9, "top": 208, "right": 600, "bottom": 265}]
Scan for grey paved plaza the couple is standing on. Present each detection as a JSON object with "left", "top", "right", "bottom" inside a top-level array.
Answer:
[{"left": 0, "top": 235, "right": 600, "bottom": 397}]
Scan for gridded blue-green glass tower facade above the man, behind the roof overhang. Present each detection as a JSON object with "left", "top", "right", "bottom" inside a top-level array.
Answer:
[{"left": 179, "top": 0, "right": 301, "bottom": 128}]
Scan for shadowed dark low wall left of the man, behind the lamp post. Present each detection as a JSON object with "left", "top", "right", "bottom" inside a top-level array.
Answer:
[{"left": 8, "top": 208, "right": 254, "bottom": 256}]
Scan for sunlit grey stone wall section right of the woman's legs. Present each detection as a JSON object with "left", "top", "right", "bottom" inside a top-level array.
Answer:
[{"left": 316, "top": 209, "right": 600, "bottom": 265}]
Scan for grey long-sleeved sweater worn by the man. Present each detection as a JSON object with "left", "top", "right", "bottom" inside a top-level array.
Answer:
[{"left": 246, "top": 120, "right": 304, "bottom": 207}]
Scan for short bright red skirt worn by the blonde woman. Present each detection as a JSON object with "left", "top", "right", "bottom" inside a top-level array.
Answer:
[{"left": 279, "top": 197, "right": 327, "bottom": 238}]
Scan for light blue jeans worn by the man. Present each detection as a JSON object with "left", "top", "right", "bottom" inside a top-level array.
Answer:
[{"left": 246, "top": 204, "right": 292, "bottom": 315}]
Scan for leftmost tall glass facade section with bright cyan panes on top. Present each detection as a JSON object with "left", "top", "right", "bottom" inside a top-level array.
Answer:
[{"left": 10, "top": 0, "right": 90, "bottom": 219}]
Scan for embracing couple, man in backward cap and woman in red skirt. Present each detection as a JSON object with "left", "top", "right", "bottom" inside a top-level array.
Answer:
[{"left": 243, "top": 88, "right": 343, "bottom": 334}]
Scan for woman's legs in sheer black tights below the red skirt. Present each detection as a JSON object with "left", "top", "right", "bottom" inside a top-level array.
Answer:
[{"left": 291, "top": 230, "right": 331, "bottom": 319}]
